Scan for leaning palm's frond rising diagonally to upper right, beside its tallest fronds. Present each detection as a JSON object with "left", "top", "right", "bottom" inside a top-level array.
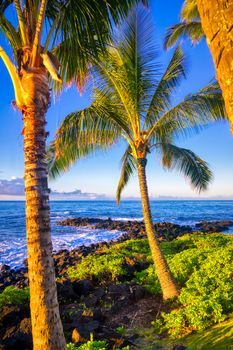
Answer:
[{"left": 145, "top": 47, "right": 186, "bottom": 126}]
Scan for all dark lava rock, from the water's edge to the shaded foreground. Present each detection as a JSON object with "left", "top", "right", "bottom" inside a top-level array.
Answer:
[{"left": 0, "top": 218, "right": 233, "bottom": 350}]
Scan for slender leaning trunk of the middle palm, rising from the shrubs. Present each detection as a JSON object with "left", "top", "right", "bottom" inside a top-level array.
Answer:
[{"left": 137, "top": 158, "right": 179, "bottom": 300}]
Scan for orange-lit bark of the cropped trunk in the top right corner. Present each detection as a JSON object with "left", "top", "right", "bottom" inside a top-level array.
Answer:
[{"left": 197, "top": 0, "right": 233, "bottom": 132}]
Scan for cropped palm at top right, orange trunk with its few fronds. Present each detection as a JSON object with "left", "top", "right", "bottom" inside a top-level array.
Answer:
[{"left": 164, "top": 0, "right": 233, "bottom": 133}]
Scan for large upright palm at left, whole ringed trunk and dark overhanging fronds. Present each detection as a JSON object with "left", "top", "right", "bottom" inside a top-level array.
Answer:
[{"left": 0, "top": 0, "right": 146, "bottom": 350}]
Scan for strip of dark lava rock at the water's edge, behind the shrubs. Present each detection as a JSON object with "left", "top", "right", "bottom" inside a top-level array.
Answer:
[{"left": 0, "top": 217, "right": 233, "bottom": 293}]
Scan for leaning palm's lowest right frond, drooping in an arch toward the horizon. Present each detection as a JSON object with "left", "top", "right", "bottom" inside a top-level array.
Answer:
[{"left": 157, "top": 143, "right": 212, "bottom": 192}]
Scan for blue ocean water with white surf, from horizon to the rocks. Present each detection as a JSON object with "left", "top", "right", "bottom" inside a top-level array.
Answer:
[{"left": 0, "top": 200, "right": 233, "bottom": 267}]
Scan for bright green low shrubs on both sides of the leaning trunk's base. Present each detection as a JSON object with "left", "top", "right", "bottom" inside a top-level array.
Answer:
[{"left": 67, "top": 233, "right": 233, "bottom": 339}]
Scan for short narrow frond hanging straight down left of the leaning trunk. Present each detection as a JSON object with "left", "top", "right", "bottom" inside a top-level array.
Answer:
[{"left": 116, "top": 146, "right": 136, "bottom": 204}]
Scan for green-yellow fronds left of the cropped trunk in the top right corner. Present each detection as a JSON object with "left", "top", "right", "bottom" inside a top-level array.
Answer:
[{"left": 164, "top": 0, "right": 204, "bottom": 49}]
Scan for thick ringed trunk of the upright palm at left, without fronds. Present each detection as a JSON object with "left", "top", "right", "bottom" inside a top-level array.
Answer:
[{"left": 21, "top": 70, "right": 66, "bottom": 350}]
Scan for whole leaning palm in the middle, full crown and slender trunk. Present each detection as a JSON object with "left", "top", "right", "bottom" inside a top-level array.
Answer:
[{"left": 48, "top": 6, "right": 225, "bottom": 299}]
